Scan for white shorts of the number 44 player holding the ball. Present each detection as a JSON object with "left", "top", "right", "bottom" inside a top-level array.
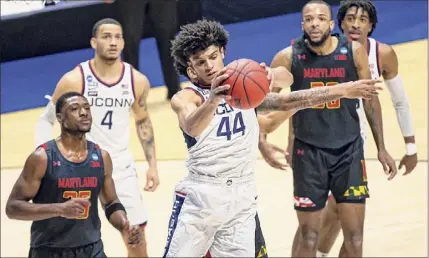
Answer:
[{"left": 164, "top": 174, "right": 257, "bottom": 257}]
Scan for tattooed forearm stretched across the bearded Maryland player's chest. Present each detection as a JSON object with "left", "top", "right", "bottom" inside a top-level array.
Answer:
[{"left": 258, "top": 85, "right": 344, "bottom": 111}]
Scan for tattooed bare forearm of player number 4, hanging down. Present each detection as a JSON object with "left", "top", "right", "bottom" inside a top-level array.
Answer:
[{"left": 136, "top": 117, "right": 156, "bottom": 167}]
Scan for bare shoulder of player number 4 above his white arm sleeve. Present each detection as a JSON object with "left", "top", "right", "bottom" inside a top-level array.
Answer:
[{"left": 52, "top": 66, "right": 84, "bottom": 103}]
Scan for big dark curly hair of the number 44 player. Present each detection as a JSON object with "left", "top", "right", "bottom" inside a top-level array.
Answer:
[{"left": 171, "top": 19, "right": 229, "bottom": 77}]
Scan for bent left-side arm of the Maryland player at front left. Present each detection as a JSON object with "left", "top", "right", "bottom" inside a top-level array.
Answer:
[{"left": 6, "top": 148, "right": 84, "bottom": 221}]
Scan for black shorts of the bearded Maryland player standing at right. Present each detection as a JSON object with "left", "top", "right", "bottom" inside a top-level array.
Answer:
[{"left": 292, "top": 136, "right": 369, "bottom": 211}]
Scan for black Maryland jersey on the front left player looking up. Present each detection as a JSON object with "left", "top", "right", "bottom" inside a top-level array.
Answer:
[{"left": 31, "top": 140, "right": 104, "bottom": 248}]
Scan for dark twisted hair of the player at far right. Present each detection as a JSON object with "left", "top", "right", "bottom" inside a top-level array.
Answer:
[{"left": 337, "top": 0, "right": 378, "bottom": 36}]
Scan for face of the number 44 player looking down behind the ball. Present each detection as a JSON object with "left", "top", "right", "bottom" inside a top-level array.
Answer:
[{"left": 188, "top": 45, "right": 225, "bottom": 86}]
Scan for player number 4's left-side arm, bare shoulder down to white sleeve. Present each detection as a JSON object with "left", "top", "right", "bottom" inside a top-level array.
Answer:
[{"left": 34, "top": 67, "right": 82, "bottom": 147}]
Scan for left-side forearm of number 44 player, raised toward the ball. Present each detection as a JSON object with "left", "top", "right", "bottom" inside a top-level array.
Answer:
[{"left": 182, "top": 101, "right": 219, "bottom": 137}]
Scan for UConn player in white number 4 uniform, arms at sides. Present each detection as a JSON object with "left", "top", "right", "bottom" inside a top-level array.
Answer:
[{"left": 35, "top": 19, "right": 159, "bottom": 257}]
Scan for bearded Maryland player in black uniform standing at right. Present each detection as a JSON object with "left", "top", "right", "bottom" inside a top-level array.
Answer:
[{"left": 260, "top": 0, "right": 397, "bottom": 257}]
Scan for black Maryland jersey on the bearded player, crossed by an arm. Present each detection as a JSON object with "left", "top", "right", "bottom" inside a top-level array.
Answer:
[{"left": 291, "top": 34, "right": 360, "bottom": 148}]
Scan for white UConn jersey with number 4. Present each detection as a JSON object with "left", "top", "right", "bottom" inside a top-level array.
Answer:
[{"left": 80, "top": 61, "right": 134, "bottom": 158}]
